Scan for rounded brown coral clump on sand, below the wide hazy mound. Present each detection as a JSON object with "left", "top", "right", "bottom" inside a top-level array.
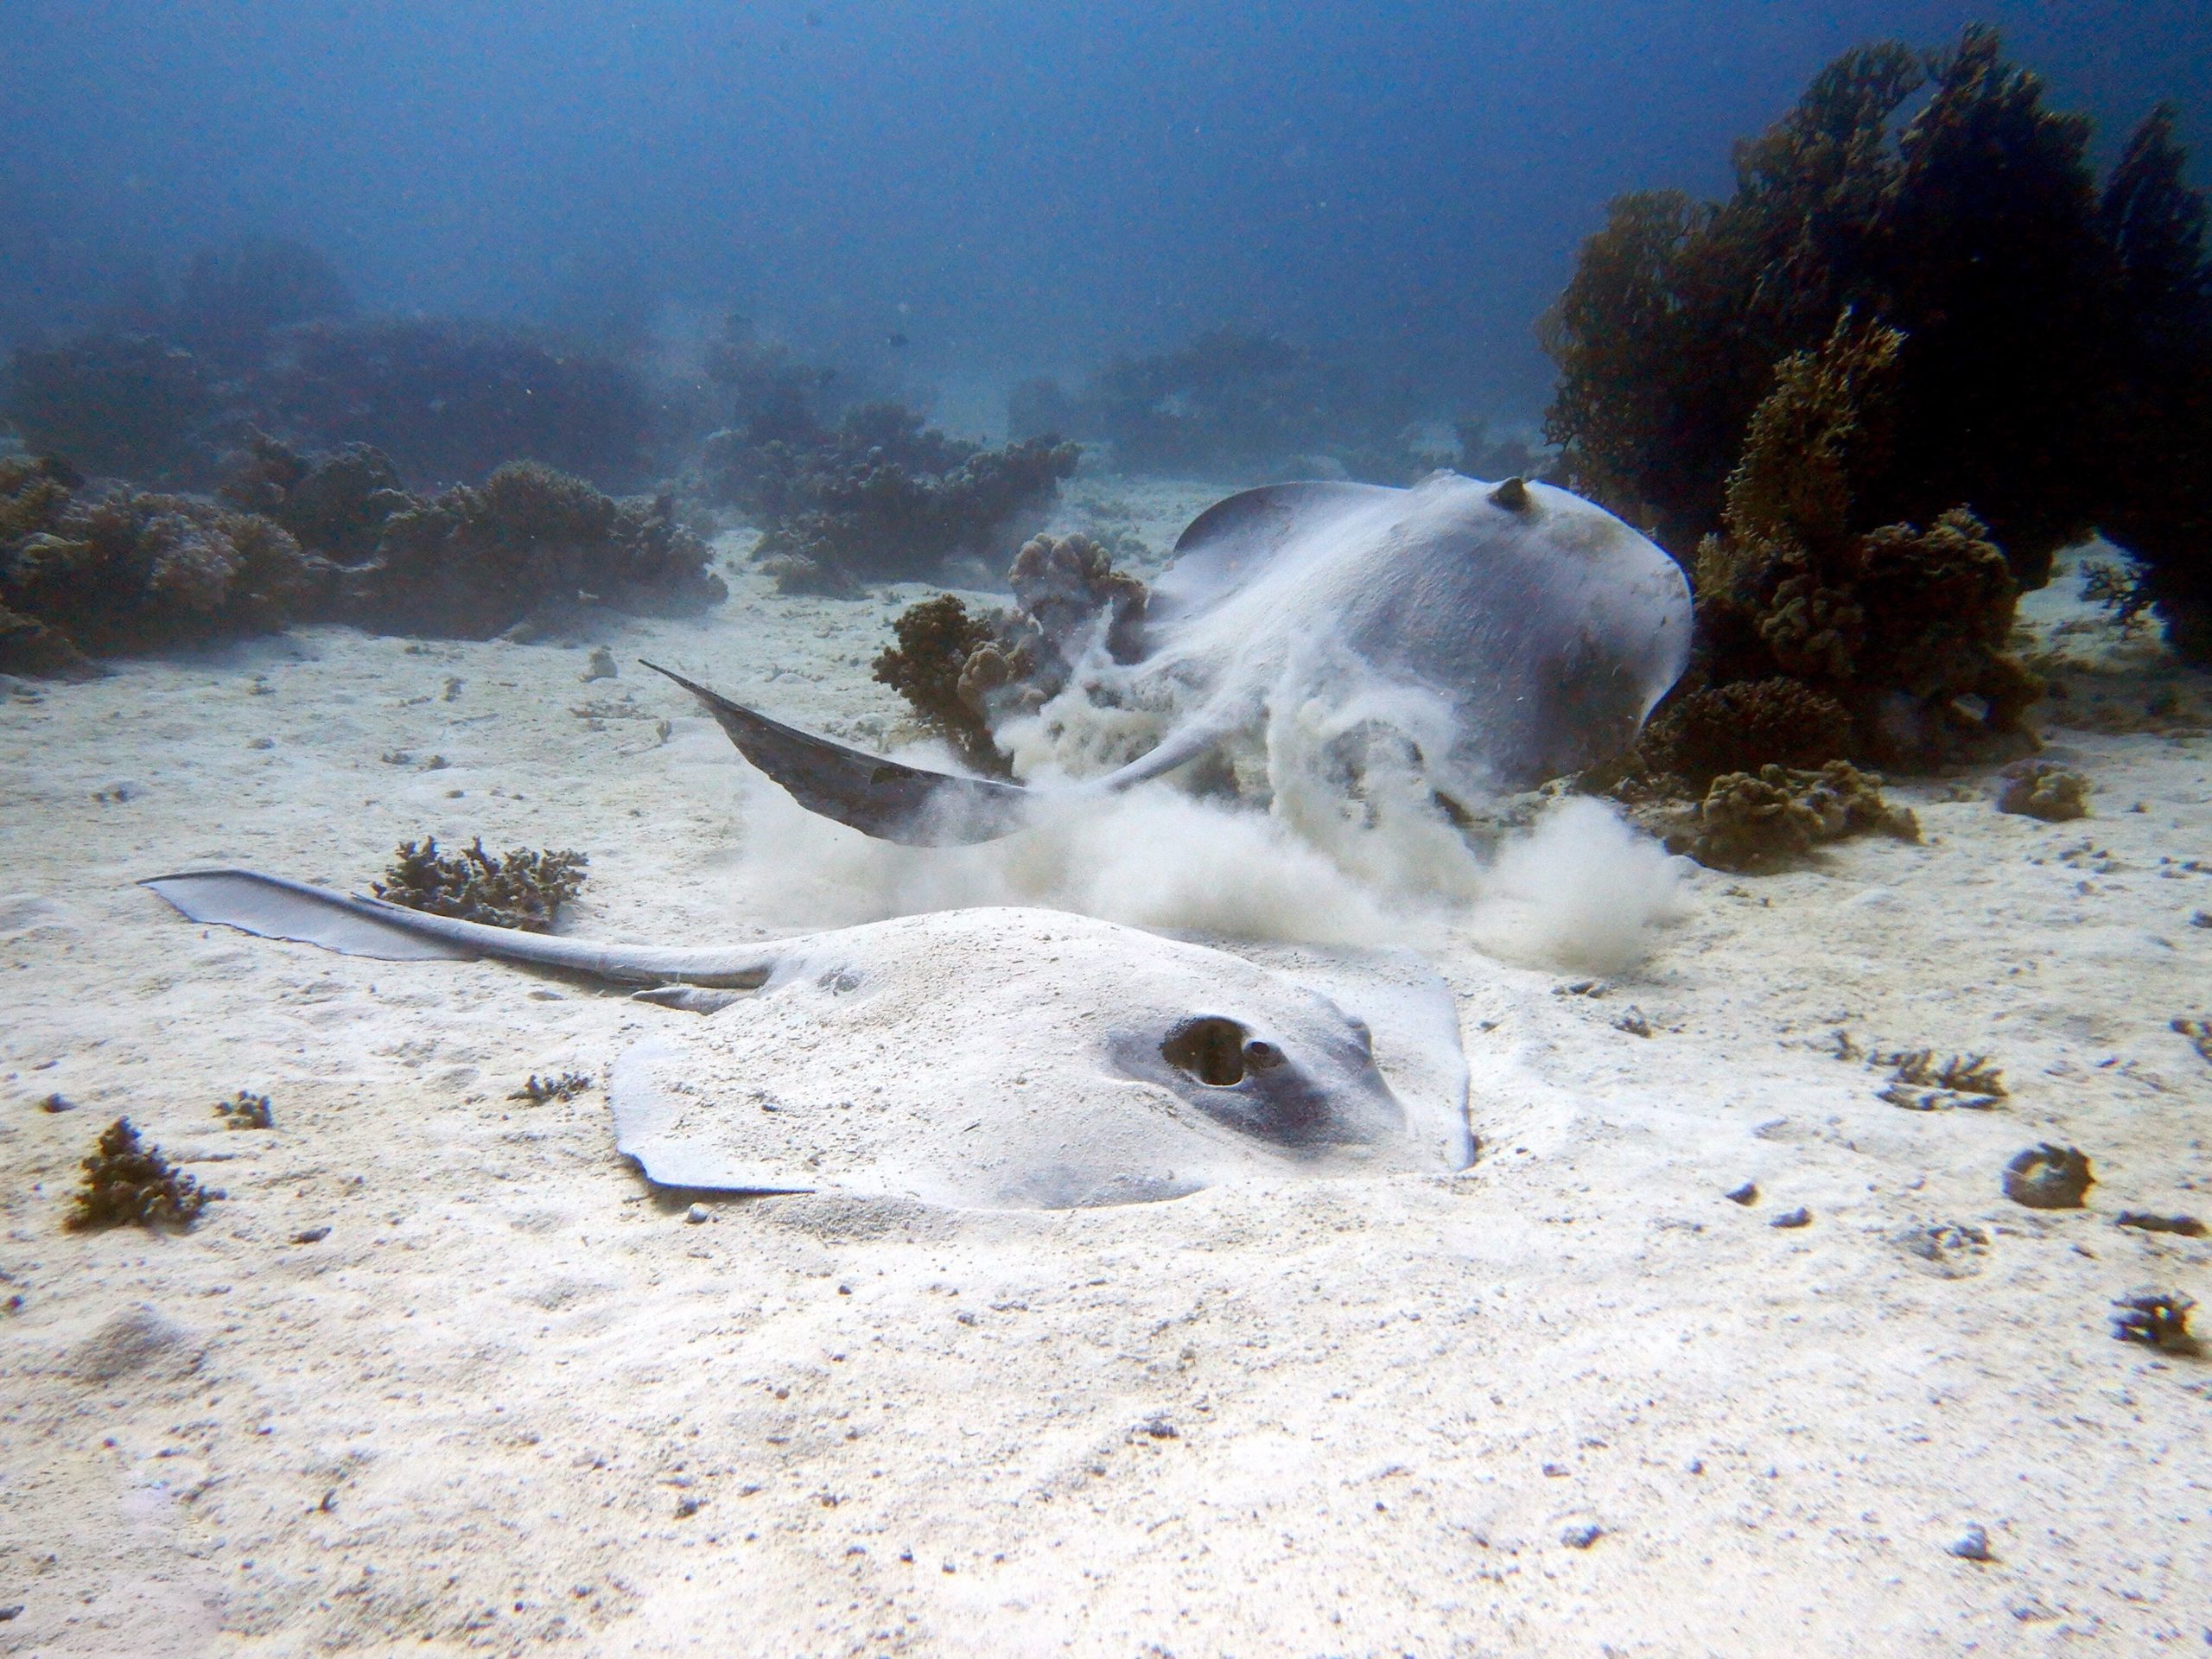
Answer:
[{"left": 345, "top": 460, "right": 728, "bottom": 639}]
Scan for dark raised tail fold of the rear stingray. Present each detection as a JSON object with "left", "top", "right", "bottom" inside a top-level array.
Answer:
[{"left": 639, "top": 659, "right": 1028, "bottom": 847}]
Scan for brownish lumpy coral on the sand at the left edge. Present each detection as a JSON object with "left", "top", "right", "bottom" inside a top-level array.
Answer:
[{"left": 0, "top": 458, "right": 321, "bottom": 672}]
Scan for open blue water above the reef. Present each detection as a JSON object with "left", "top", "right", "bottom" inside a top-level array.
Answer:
[{"left": 0, "top": 0, "right": 2212, "bottom": 429}]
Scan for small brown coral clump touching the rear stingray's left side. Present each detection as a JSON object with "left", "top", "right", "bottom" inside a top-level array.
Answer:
[{"left": 876, "top": 536, "right": 1150, "bottom": 777}]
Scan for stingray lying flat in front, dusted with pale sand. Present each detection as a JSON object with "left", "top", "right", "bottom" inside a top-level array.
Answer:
[{"left": 143, "top": 869, "right": 1473, "bottom": 1210}]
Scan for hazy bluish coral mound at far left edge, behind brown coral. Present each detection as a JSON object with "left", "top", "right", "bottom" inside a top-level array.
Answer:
[{"left": 0, "top": 334, "right": 217, "bottom": 482}]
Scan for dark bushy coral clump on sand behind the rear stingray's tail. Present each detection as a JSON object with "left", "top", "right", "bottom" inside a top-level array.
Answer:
[{"left": 696, "top": 403, "right": 1079, "bottom": 593}]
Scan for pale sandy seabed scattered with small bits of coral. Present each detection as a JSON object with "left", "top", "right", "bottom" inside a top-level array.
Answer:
[{"left": 0, "top": 473, "right": 2212, "bottom": 1659}]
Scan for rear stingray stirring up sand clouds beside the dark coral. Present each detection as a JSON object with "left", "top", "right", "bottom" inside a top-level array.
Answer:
[{"left": 646, "top": 474, "right": 1690, "bottom": 845}]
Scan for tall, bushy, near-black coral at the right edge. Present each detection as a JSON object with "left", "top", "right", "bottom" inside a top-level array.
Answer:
[{"left": 1541, "top": 29, "right": 2212, "bottom": 658}]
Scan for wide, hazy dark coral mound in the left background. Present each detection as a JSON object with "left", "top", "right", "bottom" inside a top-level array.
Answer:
[{"left": 244, "top": 319, "right": 652, "bottom": 486}]
